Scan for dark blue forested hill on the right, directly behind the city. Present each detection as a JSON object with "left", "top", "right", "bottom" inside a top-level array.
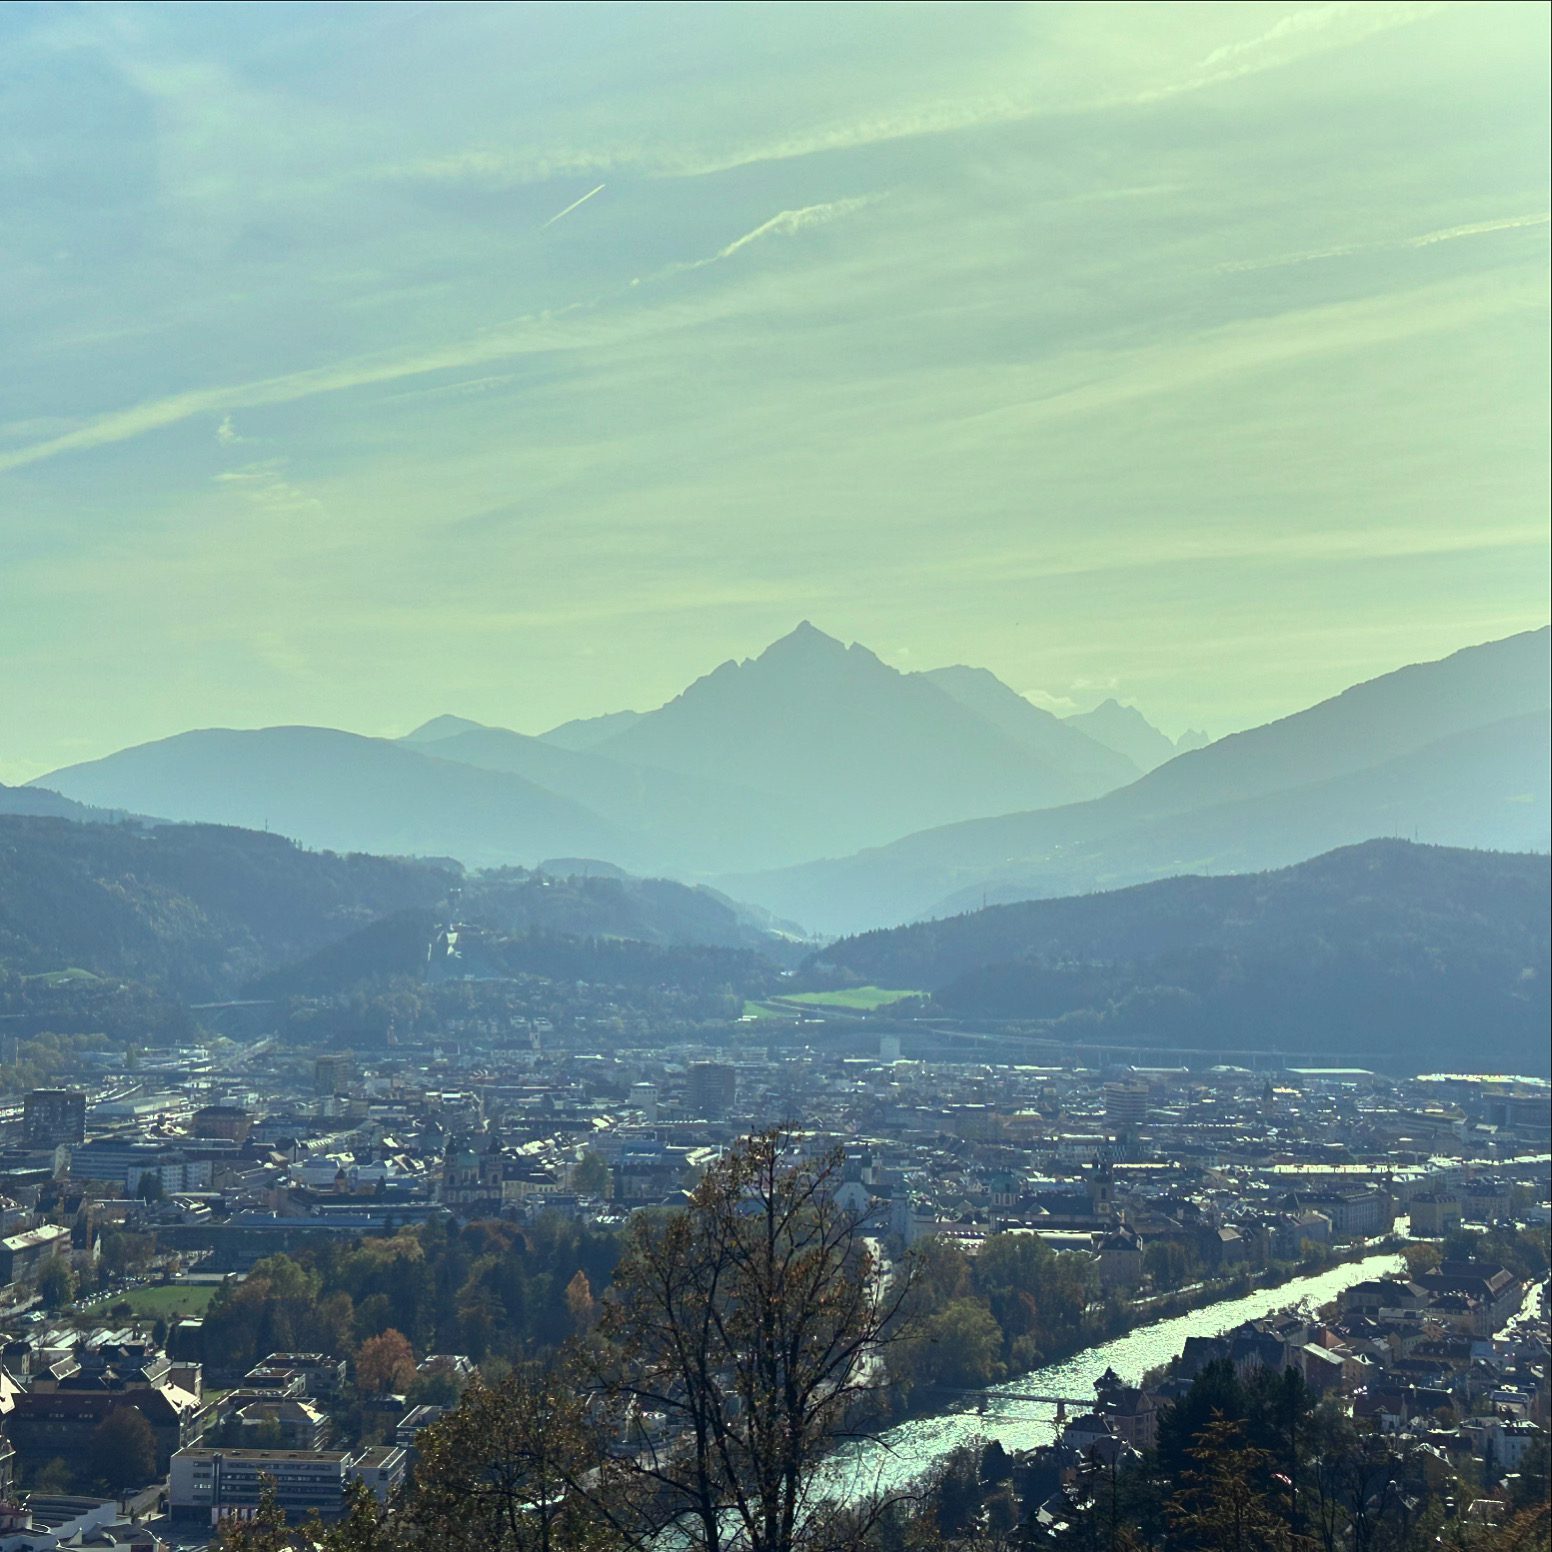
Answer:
[{"left": 809, "top": 841, "right": 1552, "bottom": 1072}]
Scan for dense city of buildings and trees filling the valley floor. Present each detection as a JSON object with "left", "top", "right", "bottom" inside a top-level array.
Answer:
[{"left": 0, "top": 1003, "right": 1552, "bottom": 1549}]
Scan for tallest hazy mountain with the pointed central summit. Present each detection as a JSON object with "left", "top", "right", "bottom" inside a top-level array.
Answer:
[{"left": 594, "top": 622, "right": 1142, "bottom": 857}]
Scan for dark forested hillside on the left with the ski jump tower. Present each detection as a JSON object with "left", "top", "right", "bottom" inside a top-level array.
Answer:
[{"left": 0, "top": 816, "right": 798, "bottom": 1001}]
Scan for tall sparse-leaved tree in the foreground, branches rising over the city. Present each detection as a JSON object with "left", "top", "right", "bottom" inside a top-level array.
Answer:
[{"left": 599, "top": 1130, "right": 909, "bottom": 1552}]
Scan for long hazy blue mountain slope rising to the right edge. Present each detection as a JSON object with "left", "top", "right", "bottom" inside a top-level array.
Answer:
[{"left": 725, "top": 630, "right": 1552, "bottom": 931}]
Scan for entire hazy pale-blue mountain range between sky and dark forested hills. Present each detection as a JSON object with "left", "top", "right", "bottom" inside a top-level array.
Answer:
[{"left": 18, "top": 622, "right": 1552, "bottom": 934}]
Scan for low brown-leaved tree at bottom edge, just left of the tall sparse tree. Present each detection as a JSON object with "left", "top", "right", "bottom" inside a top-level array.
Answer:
[{"left": 404, "top": 1369, "right": 615, "bottom": 1552}]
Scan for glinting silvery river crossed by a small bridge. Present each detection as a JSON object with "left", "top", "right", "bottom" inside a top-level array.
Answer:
[{"left": 830, "top": 1252, "right": 1405, "bottom": 1499}]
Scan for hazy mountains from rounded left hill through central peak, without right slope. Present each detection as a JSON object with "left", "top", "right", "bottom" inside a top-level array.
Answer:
[{"left": 21, "top": 624, "right": 1138, "bottom": 877}]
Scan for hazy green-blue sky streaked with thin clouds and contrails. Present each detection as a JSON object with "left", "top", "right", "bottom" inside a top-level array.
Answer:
[{"left": 0, "top": 0, "right": 1549, "bottom": 781}]
